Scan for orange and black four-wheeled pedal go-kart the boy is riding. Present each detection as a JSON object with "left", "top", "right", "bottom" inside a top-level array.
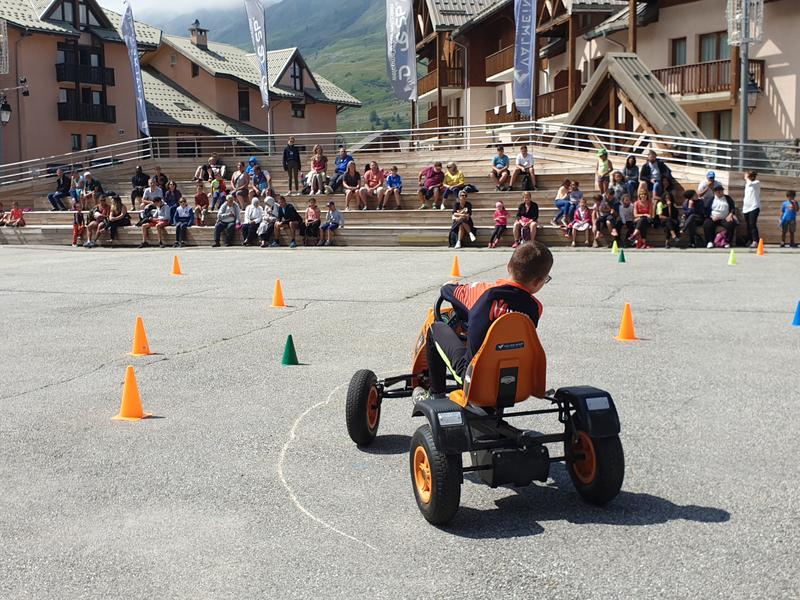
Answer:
[{"left": 346, "top": 297, "right": 625, "bottom": 525}]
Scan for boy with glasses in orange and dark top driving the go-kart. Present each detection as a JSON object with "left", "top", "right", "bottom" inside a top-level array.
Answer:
[{"left": 427, "top": 242, "right": 553, "bottom": 397}]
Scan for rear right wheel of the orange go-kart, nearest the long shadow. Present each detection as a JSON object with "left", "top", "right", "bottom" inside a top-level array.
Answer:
[{"left": 564, "top": 427, "right": 625, "bottom": 505}]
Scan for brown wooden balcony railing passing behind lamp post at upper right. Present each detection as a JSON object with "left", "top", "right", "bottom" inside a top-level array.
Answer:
[{"left": 653, "top": 60, "right": 764, "bottom": 96}]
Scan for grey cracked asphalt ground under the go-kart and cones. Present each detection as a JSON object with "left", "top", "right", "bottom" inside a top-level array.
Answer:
[{"left": 0, "top": 246, "right": 800, "bottom": 599}]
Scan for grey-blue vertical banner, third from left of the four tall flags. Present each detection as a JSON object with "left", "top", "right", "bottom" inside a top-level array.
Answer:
[{"left": 386, "top": 0, "right": 417, "bottom": 100}]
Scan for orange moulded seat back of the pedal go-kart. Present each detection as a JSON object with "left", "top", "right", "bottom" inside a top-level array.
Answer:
[{"left": 450, "top": 313, "right": 547, "bottom": 408}]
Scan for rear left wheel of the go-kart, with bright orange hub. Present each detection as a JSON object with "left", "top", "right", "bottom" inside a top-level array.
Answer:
[{"left": 409, "top": 424, "right": 461, "bottom": 525}]
